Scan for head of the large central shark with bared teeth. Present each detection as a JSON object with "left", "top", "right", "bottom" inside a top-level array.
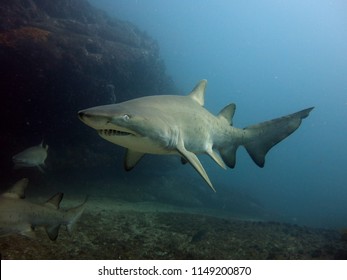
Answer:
[{"left": 78, "top": 102, "right": 177, "bottom": 152}]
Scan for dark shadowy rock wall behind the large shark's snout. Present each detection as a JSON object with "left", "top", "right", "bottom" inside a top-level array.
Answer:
[{"left": 0, "top": 0, "right": 175, "bottom": 178}]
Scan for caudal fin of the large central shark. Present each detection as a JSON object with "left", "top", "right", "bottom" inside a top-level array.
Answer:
[{"left": 242, "top": 107, "right": 314, "bottom": 167}]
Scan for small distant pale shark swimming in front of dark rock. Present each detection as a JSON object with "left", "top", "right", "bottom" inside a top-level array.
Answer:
[{"left": 12, "top": 141, "right": 48, "bottom": 172}]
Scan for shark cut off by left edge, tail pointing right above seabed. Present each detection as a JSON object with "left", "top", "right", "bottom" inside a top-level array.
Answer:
[{"left": 0, "top": 178, "right": 86, "bottom": 240}]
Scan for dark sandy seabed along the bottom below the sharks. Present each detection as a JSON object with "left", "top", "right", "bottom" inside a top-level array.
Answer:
[{"left": 0, "top": 197, "right": 347, "bottom": 259}]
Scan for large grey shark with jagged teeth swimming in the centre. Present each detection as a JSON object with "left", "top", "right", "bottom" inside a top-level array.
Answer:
[{"left": 78, "top": 80, "right": 313, "bottom": 191}]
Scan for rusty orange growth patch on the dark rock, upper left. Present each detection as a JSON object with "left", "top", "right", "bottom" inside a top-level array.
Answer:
[{"left": 0, "top": 26, "right": 50, "bottom": 47}]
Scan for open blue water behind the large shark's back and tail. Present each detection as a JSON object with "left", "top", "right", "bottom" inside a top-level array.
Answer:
[{"left": 90, "top": 0, "right": 347, "bottom": 228}]
